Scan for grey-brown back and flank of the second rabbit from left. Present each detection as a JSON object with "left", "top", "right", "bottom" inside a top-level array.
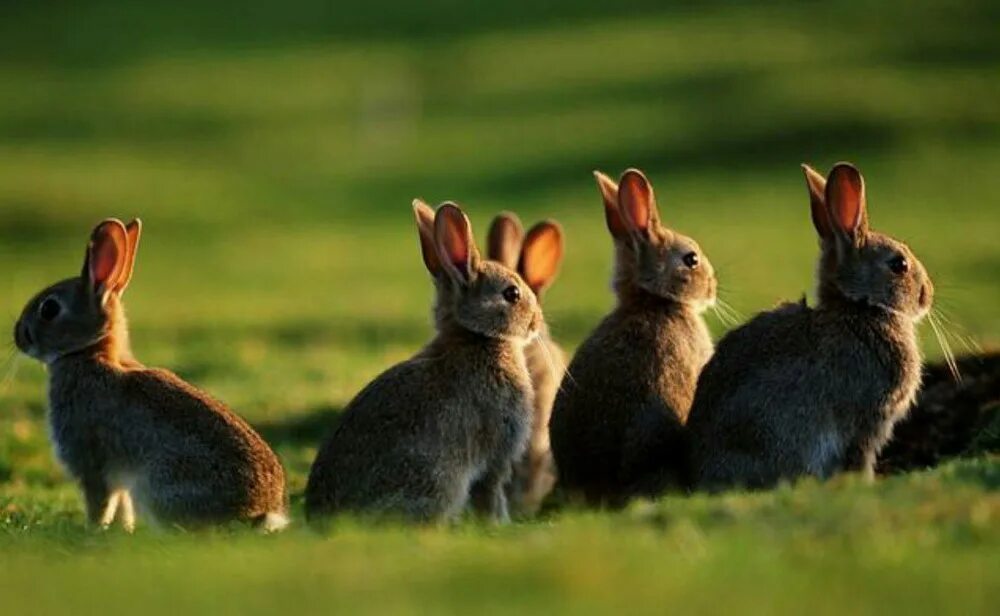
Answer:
[{"left": 306, "top": 340, "right": 531, "bottom": 521}]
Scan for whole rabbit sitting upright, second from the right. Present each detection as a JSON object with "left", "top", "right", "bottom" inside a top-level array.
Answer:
[{"left": 549, "top": 169, "right": 717, "bottom": 507}]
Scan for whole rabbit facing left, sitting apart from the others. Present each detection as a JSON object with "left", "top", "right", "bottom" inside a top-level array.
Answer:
[{"left": 14, "top": 219, "right": 288, "bottom": 532}]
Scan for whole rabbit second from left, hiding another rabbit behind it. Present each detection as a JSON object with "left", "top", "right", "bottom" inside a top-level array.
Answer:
[{"left": 305, "top": 201, "right": 542, "bottom": 524}]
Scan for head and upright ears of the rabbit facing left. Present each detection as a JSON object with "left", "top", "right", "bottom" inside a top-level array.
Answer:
[{"left": 14, "top": 218, "right": 142, "bottom": 363}]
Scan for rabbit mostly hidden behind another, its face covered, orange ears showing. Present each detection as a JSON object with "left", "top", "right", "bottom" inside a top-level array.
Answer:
[{"left": 487, "top": 212, "right": 566, "bottom": 516}]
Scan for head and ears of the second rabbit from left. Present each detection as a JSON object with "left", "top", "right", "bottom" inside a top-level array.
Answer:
[{"left": 413, "top": 200, "right": 542, "bottom": 342}]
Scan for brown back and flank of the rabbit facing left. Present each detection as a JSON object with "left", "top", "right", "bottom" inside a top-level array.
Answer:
[{"left": 50, "top": 364, "right": 286, "bottom": 524}]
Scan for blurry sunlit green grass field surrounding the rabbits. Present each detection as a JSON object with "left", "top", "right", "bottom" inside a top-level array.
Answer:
[{"left": 0, "top": 0, "right": 1000, "bottom": 614}]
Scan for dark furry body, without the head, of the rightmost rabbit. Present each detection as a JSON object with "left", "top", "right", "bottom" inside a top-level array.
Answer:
[{"left": 688, "top": 302, "right": 920, "bottom": 489}]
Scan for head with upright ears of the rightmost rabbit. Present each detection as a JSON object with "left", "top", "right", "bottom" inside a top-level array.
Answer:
[{"left": 802, "top": 163, "right": 934, "bottom": 321}]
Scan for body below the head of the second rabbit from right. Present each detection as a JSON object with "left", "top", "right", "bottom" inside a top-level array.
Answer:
[{"left": 550, "top": 308, "right": 712, "bottom": 504}]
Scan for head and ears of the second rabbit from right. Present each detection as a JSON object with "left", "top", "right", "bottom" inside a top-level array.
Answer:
[{"left": 594, "top": 169, "right": 717, "bottom": 312}]
